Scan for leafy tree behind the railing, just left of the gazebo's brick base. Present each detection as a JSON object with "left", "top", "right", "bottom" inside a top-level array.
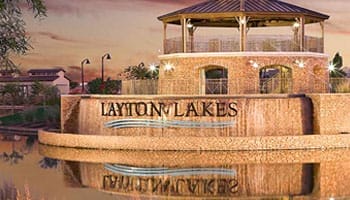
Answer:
[{"left": 123, "top": 62, "right": 159, "bottom": 80}]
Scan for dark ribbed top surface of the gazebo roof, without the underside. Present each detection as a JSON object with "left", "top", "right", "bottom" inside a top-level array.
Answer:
[{"left": 158, "top": 0, "right": 329, "bottom": 20}]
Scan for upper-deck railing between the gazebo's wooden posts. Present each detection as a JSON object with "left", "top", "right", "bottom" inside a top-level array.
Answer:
[{"left": 164, "top": 35, "right": 323, "bottom": 54}]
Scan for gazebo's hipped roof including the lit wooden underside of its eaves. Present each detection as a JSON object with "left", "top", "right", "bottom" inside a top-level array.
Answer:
[{"left": 158, "top": 0, "right": 329, "bottom": 24}]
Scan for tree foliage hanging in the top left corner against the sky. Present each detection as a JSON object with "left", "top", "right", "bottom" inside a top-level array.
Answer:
[{"left": 0, "top": 0, "right": 46, "bottom": 60}]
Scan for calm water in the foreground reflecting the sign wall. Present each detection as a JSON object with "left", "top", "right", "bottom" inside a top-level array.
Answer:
[{"left": 0, "top": 135, "right": 350, "bottom": 200}]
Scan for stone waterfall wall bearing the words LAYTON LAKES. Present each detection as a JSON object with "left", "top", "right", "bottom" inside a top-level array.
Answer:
[{"left": 61, "top": 95, "right": 313, "bottom": 137}]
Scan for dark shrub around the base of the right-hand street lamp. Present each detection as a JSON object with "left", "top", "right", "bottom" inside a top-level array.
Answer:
[{"left": 88, "top": 78, "right": 121, "bottom": 94}]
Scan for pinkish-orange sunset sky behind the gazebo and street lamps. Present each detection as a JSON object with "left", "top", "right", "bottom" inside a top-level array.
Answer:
[{"left": 14, "top": 0, "right": 350, "bottom": 81}]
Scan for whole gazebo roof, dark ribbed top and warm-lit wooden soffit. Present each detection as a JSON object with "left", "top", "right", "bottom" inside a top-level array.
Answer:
[{"left": 158, "top": 0, "right": 329, "bottom": 27}]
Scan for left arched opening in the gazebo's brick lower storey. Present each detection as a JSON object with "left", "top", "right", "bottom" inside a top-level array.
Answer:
[{"left": 199, "top": 65, "right": 228, "bottom": 94}]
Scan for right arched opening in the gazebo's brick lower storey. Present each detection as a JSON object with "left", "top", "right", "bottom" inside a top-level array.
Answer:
[{"left": 259, "top": 64, "right": 293, "bottom": 93}]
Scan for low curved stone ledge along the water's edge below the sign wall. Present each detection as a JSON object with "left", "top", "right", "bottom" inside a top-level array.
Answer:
[{"left": 39, "top": 131, "right": 350, "bottom": 151}]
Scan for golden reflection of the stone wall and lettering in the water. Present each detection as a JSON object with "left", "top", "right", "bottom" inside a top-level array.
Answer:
[{"left": 40, "top": 146, "right": 350, "bottom": 199}]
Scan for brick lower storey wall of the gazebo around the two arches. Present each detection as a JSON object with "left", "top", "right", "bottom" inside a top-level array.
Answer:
[{"left": 158, "top": 52, "right": 329, "bottom": 95}]
